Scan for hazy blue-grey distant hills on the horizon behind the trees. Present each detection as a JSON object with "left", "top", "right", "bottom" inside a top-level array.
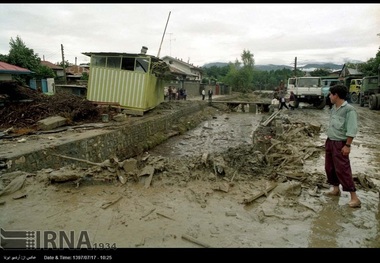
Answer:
[{"left": 203, "top": 62, "right": 343, "bottom": 71}]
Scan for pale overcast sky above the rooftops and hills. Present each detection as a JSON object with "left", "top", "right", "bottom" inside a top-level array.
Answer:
[{"left": 0, "top": 3, "right": 380, "bottom": 66}]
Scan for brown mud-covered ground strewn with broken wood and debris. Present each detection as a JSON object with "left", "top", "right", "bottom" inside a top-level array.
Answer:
[{"left": 0, "top": 92, "right": 380, "bottom": 253}]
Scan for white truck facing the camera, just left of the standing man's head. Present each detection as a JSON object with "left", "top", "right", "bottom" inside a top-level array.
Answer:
[{"left": 287, "top": 77, "right": 326, "bottom": 109}]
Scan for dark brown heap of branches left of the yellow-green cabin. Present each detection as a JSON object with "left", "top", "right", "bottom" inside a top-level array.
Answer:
[{"left": 0, "top": 81, "right": 102, "bottom": 129}]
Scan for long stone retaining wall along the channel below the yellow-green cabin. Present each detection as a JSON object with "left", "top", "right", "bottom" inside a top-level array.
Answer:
[{"left": 0, "top": 103, "right": 206, "bottom": 173}]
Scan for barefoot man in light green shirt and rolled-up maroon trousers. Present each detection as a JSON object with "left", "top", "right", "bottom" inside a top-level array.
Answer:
[{"left": 325, "top": 84, "right": 361, "bottom": 208}]
